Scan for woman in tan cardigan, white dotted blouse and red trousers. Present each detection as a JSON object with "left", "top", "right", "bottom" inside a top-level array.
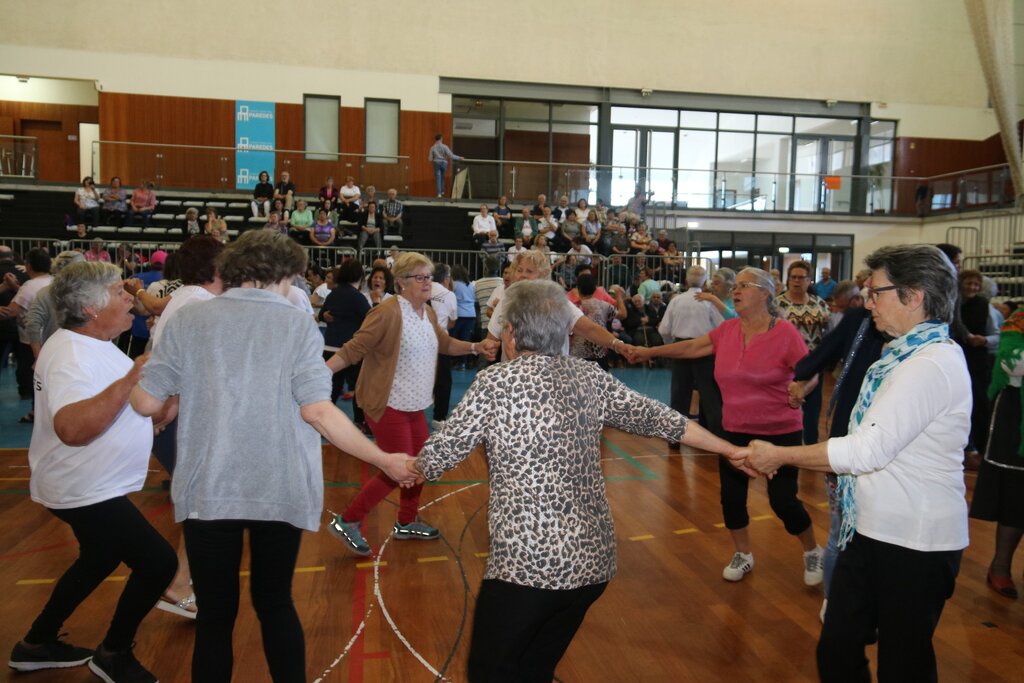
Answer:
[{"left": 319, "top": 252, "right": 498, "bottom": 555}]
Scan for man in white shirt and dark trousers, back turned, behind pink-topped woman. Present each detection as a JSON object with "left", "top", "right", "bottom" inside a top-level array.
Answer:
[{"left": 657, "top": 265, "right": 724, "bottom": 445}]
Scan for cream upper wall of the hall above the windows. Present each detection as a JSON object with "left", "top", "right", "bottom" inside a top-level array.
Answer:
[{"left": 0, "top": 0, "right": 995, "bottom": 138}]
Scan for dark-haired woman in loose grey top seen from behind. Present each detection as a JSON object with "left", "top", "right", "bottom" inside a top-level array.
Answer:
[{"left": 131, "top": 230, "right": 413, "bottom": 682}]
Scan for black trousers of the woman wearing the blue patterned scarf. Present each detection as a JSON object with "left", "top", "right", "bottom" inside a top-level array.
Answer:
[{"left": 817, "top": 533, "right": 964, "bottom": 683}]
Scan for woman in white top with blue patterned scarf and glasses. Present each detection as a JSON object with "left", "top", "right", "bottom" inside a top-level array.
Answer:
[{"left": 748, "top": 246, "right": 971, "bottom": 681}]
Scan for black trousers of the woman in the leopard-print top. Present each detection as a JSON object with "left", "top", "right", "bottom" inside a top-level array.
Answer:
[{"left": 468, "top": 579, "right": 608, "bottom": 683}]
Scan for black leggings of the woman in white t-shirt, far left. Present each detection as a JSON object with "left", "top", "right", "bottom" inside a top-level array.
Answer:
[{"left": 25, "top": 496, "right": 178, "bottom": 651}]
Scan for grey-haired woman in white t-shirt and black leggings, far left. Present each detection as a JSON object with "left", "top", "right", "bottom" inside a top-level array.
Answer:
[{"left": 10, "top": 262, "right": 177, "bottom": 681}]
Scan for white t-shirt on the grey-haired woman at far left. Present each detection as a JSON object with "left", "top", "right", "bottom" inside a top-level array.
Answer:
[{"left": 29, "top": 330, "right": 153, "bottom": 509}]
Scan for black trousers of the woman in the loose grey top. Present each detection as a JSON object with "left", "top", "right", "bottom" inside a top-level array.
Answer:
[{"left": 184, "top": 519, "right": 306, "bottom": 683}]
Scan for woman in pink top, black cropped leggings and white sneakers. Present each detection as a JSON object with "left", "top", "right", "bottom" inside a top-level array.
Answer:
[{"left": 631, "top": 268, "right": 823, "bottom": 586}]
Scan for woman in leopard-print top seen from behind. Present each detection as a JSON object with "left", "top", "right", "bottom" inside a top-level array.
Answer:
[{"left": 411, "top": 281, "right": 749, "bottom": 682}]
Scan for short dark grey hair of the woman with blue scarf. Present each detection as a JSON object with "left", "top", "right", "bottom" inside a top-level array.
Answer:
[{"left": 864, "top": 245, "right": 959, "bottom": 323}]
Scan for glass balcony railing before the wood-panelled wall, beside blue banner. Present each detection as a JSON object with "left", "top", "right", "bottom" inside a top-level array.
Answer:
[{"left": 92, "top": 140, "right": 409, "bottom": 197}]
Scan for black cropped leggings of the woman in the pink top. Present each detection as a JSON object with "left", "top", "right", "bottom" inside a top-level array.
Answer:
[{"left": 718, "top": 431, "right": 811, "bottom": 536}]
